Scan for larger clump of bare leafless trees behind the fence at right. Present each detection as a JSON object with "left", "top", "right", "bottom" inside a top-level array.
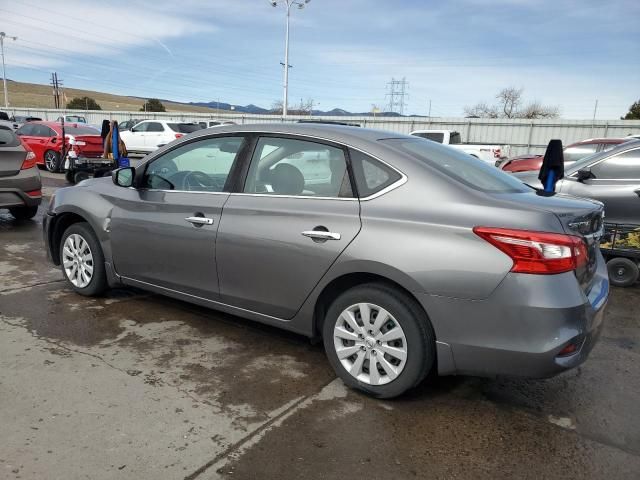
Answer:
[{"left": 464, "top": 87, "right": 560, "bottom": 118}]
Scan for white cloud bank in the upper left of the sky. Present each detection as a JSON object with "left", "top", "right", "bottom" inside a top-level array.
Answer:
[{"left": 0, "top": 0, "right": 217, "bottom": 67}]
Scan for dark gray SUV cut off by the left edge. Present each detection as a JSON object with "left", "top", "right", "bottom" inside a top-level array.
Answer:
[{"left": 0, "top": 126, "right": 42, "bottom": 220}]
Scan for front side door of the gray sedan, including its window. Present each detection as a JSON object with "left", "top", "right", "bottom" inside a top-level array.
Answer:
[{"left": 110, "top": 136, "right": 246, "bottom": 300}]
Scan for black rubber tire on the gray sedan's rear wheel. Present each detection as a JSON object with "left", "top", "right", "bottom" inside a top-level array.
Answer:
[{"left": 322, "top": 283, "right": 435, "bottom": 398}]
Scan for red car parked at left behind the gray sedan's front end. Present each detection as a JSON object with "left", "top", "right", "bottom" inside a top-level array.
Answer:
[{"left": 16, "top": 122, "right": 103, "bottom": 172}]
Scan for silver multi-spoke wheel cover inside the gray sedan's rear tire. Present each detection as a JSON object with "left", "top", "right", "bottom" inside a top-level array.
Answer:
[{"left": 333, "top": 303, "right": 407, "bottom": 385}]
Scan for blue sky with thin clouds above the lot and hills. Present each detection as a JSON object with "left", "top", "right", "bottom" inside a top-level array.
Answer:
[{"left": 0, "top": 0, "right": 640, "bottom": 119}]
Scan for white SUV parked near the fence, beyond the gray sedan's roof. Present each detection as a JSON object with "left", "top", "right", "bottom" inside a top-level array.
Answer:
[{"left": 120, "top": 120, "right": 202, "bottom": 153}]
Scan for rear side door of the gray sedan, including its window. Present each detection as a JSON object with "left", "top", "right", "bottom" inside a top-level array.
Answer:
[{"left": 216, "top": 135, "right": 360, "bottom": 319}]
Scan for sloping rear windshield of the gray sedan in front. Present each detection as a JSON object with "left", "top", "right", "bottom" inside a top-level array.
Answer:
[{"left": 381, "top": 138, "right": 531, "bottom": 193}]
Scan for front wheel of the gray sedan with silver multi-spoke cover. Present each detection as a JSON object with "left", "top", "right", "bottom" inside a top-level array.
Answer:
[{"left": 60, "top": 222, "right": 107, "bottom": 296}]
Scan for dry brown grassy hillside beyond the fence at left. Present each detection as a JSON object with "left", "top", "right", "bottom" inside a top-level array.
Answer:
[{"left": 0, "top": 81, "right": 217, "bottom": 113}]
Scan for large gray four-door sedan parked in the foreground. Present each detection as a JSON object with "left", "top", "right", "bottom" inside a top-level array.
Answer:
[{"left": 44, "top": 124, "right": 609, "bottom": 398}]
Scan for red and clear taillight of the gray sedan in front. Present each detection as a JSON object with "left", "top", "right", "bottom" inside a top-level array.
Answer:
[{"left": 473, "top": 227, "right": 587, "bottom": 275}]
